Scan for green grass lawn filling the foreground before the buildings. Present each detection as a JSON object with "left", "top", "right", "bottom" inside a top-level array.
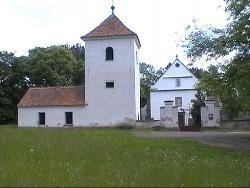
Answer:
[{"left": 0, "top": 126, "right": 250, "bottom": 187}]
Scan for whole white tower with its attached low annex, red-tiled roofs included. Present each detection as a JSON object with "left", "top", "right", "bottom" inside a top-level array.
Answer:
[{"left": 18, "top": 7, "right": 141, "bottom": 127}]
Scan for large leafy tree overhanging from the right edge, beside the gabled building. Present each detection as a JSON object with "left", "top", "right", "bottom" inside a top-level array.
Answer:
[{"left": 183, "top": 0, "right": 250, "bottom": 118}]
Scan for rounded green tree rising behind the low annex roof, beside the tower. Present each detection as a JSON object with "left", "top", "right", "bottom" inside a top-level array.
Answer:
[{"left": 28, "top": 46, "right": 84, "bottom": 87}]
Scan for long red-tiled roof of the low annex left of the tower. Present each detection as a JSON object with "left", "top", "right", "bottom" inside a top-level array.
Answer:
[{"left": 17, "top": 86, "right": 85, "bottom": 107}]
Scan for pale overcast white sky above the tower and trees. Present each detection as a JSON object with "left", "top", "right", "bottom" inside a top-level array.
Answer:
[{"left": 0, "top": 0, "right": 228, "bottom": 68}]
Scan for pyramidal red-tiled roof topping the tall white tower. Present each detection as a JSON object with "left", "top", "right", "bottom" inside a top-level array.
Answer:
[{"left": 81, "top": 13, "right": 141, "bottom": 46}]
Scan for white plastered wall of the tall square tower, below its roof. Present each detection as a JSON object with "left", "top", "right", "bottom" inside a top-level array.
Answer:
[{"left": 85, "top": 37, "right": 138, "bottom": 123}]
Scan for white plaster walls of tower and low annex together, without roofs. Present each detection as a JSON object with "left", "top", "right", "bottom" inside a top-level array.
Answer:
[{"left": 18, "top": 14, "right": 140, "bottom": 127}]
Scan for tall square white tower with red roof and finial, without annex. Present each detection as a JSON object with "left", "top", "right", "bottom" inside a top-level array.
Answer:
[{"left": 81, "top": 6, "right": 141, "bottom": 125}]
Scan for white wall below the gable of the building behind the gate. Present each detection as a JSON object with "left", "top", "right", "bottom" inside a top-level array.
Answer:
[{"left": 150, "top": 90, "right": 196, "bottom": 120}]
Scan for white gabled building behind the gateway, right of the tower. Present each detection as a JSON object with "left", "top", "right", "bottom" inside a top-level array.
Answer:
[{"left": 150, "top": 57, "right": 198, "bottom": 120}]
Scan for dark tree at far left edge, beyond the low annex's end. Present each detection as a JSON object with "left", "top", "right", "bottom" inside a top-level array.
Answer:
[{"left": 0, "top": 52, "right": 28, "bottom": 124}]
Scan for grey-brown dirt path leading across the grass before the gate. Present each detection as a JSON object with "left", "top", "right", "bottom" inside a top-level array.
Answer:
[{"left": 134, "top": 131, "right": 250, "bottom": 150}]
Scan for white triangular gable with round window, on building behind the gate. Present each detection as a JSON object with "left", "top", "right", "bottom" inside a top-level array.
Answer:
[{"left": 151, "top": 58, "right": 198, "bottom": 90}]
